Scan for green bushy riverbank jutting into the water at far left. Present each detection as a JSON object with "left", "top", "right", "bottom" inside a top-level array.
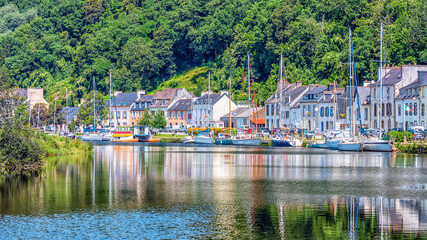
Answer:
[{"left": 0, "top": 127, "right": 93, "bottom": 170}]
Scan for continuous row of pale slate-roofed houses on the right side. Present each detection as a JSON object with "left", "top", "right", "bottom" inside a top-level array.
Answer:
[{"left": 265, "top": 65, "right": 427, "bottom": 132}]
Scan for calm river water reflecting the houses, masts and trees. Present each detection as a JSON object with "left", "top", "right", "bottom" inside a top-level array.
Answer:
[{"left": 0, "top": 144, "right": 427, "bottom": 239}]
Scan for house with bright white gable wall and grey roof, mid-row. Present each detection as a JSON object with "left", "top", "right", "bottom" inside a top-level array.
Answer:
[{"left": 192, "top": 91, "right": 237, "bottom": 128}]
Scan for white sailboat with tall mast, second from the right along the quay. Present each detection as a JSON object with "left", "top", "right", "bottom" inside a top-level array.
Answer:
[{"left": 338, "top": 29, "right": 363, "bottom": 152}]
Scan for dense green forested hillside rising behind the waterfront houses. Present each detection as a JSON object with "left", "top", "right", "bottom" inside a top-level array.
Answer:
[{"left": 0, "top": 0, "right": 427, "bottom": 102}]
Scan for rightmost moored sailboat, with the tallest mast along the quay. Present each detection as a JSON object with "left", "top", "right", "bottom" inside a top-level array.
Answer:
[{"left": 363, "top": 23, "right": 394, "bottom": 152}]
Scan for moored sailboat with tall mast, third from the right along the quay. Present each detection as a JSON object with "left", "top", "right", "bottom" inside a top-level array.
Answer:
[{"left": 271, "top": 53, "right": 302, "bottom": 147}]
